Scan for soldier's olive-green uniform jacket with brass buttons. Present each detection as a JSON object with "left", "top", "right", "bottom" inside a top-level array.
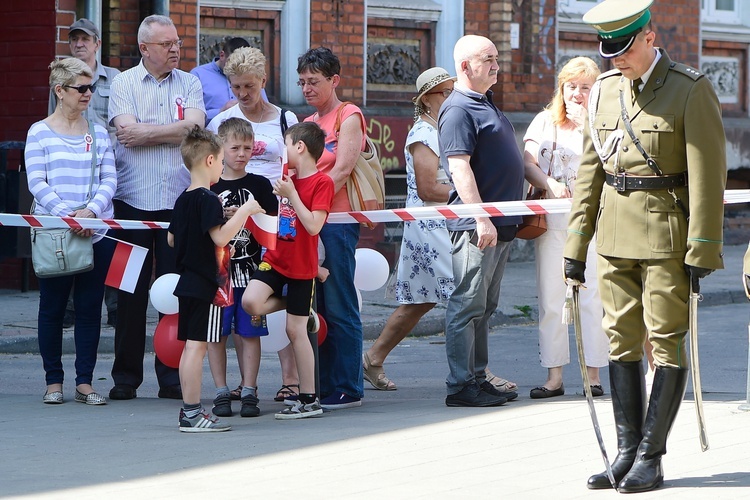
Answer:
[{"left": 564, "top": 49, "right": 726, "bottom": 269}]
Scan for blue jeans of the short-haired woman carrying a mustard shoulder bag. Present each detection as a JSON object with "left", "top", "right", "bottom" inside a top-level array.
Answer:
[{"left": 317, "top": 224, "right": 364, "bottom": 398}]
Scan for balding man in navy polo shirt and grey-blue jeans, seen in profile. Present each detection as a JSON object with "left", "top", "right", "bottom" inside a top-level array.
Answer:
[{"left": 438, "top": 35, "right": 524, "bottom": 406}]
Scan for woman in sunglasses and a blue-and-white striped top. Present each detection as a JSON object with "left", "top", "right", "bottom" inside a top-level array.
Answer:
[{"left": 25, "top": 58, "right": 117, "bottom": 405}]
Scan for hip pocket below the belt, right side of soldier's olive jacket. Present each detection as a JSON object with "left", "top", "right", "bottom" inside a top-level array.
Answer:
[{"left": 646, "top": 192, "right": 687, "bottom": 252}]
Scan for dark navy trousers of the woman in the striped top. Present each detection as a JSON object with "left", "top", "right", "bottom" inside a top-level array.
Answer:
[{"left": 37, "top": 238, "right": 115, "bottom": 385}]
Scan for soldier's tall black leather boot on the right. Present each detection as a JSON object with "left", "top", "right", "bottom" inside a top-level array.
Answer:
[{"left": 618, "top": 367, "right": 688, "bottom": 493}]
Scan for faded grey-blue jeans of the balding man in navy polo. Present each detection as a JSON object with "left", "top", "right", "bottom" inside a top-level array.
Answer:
[{"left": 445, "top": 230, "right": 511, "bottom": 394}]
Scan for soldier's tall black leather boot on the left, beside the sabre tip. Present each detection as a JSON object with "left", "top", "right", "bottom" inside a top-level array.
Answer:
[{"left": 586, "top": 361, "right": 646, "bottom": 490}]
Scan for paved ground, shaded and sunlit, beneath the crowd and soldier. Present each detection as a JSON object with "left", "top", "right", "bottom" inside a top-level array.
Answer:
[{"left": 0, "top": 243, "right": 750, "bottom": 499}]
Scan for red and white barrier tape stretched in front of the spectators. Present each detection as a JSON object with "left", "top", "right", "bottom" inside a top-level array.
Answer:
[{"left": 0, "top": 189, "right": 750, "bottom": 229}]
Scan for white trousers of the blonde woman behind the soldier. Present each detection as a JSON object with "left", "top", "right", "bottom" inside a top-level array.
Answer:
[{"left": 534, "top": 229, "right": 609, "bottom": 368}]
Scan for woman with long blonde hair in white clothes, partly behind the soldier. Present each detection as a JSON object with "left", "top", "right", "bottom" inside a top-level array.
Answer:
[{"left": 524, "top": 57, "right": 608, "bottom": 399}]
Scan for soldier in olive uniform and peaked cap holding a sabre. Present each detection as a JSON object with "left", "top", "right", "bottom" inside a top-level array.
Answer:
[{"left": 563, "top": 0, "right": 726, "bottom": 492}]
